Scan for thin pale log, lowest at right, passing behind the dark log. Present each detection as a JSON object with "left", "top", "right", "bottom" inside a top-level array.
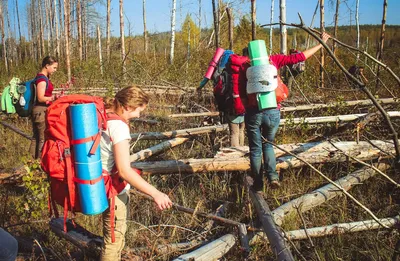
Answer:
[{"left": 250, "top": 216, "right": 400, "bottom": 243}]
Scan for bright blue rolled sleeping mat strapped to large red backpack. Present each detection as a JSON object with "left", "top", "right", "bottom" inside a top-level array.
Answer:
[{"left": 69, "top": 103, "right": 108, "bottom": 215}]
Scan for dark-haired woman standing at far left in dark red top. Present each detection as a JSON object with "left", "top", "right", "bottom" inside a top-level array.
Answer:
[{"left": 29, "top": 56, "right": 58, "bottom": 159}]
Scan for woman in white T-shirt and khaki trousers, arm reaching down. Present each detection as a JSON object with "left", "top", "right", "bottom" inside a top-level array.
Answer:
[{"left": 100, "top": 86, "right": 172, "bottom": 261}]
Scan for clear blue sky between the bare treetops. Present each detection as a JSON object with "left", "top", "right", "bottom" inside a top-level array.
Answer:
[{"left": 8, "top": 0, "right": 400, "bottom": 36}]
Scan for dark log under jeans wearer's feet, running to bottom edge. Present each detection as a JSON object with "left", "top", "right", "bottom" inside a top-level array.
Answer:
[{"left": 249, "top": 189, "right": 294, "bottom": 261}]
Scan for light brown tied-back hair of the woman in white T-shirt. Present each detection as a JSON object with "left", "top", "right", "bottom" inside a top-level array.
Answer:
[{"left": 104, "top": 86, "right": 149, "bottom": 114}]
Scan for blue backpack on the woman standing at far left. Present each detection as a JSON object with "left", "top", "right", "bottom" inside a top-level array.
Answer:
[{"left": 14, "top": 75, "right": 49, "bottom": 117}]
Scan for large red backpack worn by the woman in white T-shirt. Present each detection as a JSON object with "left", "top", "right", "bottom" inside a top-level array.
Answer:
[{"left": 41, "top": 94, "right": 126, "bottom": 242}]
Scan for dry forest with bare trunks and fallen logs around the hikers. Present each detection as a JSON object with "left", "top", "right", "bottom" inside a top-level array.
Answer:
[{"left": 0, "top": 0, "right": 400, "bottom": 261}]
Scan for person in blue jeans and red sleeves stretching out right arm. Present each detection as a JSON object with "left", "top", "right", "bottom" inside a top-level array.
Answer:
[{"left": 240, "top": 33, "right": 330, "bottom": 191}]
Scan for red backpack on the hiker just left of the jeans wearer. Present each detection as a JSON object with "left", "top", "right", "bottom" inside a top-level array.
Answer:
[{"left": 225, "top": 54, "right": 249, "bottom": 115}]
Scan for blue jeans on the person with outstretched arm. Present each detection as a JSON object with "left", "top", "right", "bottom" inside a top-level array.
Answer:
[{"left": 245, "top": 109, "right": 281, "bottom": 189}]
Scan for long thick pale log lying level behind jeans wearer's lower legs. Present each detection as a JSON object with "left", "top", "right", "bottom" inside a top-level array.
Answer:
[{"left": 131, "top": 140, "right": 394, "bottom": 175}]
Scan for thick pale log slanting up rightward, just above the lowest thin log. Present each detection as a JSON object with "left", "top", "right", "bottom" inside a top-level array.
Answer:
[{"left": 272, "top": 164, "right": 390, "bottom": 225}]
